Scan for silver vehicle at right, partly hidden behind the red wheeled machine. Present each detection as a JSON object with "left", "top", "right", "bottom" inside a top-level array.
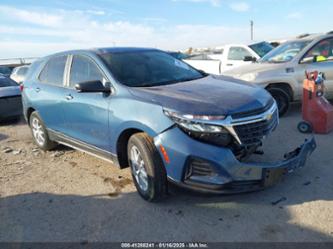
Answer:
[{"left": 224, "top": 32, "right": 333, "bottom": 116}]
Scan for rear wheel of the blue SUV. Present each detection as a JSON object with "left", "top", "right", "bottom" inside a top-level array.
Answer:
[{"left": 29, "top": 112, "right": 57, "bottom": 151}]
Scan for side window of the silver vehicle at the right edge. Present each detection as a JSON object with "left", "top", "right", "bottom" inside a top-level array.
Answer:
[{"left": 302, "top": 38, "right": 333, "bottom": 63}]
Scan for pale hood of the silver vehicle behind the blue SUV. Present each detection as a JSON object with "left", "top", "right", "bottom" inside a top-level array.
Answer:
[{"left": 223, "top": 63, "right": 287, "bottom": 77}]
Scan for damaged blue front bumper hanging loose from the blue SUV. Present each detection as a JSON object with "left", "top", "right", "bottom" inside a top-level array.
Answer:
[{"left": 155, "top": 128, "right": 316, "bottom": 194}]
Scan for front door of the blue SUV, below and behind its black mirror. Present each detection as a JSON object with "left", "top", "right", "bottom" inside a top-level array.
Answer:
[{"left": 62, "top": 55, "right": 111, "bottom": 151}]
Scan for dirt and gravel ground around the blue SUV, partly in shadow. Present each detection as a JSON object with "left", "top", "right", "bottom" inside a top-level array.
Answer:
[{"left": 0, "top": 106, "right": 333, "bottom": 242}]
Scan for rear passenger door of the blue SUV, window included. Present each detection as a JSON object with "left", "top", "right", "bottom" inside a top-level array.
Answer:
[{"left": 31, "top": 55, "right": 68, "bottom": 132}]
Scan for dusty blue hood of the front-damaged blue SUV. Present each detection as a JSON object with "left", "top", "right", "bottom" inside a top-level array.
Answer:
[{"left": 130, "top": 76, "right": 272, "bottom": 115}]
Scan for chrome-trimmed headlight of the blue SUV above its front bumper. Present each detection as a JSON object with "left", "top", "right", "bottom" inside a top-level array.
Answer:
[{"left": 163, "top": 110, "right": 232, "bottom": 146}]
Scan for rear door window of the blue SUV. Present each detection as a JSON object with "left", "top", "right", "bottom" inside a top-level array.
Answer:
[{"left": 39, "top": 56, "right": 67, "bottom": 86}]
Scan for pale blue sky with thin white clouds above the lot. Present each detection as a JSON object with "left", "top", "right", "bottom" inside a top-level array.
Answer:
[{"left": 0, "top": 0, "right": 333, "bottom": 58}]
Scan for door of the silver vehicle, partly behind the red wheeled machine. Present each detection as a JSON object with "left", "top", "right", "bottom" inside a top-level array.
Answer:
[{"left": 301, "top": 38, "right": 333, "bottom": 98}]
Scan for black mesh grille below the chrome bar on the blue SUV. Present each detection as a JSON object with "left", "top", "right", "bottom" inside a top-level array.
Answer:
[{"left": 234, "top": 110, "right": 278, "bottom": 145}]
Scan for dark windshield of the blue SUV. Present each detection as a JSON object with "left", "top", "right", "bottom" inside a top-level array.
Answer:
[{"left": 100, "top": 51, "right": 206, "bottom": 87}]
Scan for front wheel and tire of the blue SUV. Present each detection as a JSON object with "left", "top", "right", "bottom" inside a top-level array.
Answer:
[{"left": 127, "top": 133, "right": 168, "bottom": 202}]
